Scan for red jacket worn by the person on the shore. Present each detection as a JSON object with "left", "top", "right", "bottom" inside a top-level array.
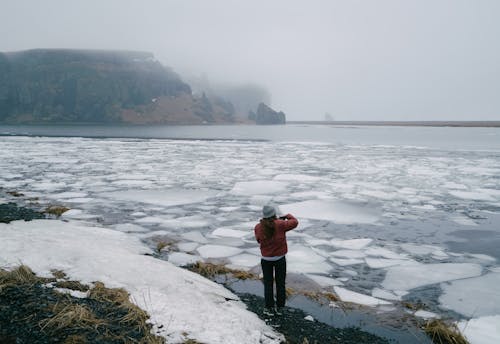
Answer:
[{"left": 254, "top": 214, "right": 299, "bottom": 257}]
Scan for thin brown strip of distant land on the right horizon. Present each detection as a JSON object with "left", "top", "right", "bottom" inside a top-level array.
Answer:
[{"left": 287, "top": 121, "right": 500, "bottom": 128}]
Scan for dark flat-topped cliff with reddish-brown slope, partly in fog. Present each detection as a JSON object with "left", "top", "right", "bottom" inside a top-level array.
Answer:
[{"left": 0, "top": 49, "right": 244, "bottom": 124}]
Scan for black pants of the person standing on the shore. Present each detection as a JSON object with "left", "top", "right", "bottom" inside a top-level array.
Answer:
[{"left": 260, "top": 257, "right": 286, "bottom": 308}]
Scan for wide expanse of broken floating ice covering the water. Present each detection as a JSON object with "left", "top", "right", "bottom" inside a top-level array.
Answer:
[{"left": 0, "top": 137, "right": 500, "bottom": 343}]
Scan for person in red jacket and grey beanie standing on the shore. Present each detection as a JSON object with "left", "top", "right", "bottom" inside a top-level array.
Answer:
[{"left": 254, "top": 205, "right": 299, "bottom": 314}]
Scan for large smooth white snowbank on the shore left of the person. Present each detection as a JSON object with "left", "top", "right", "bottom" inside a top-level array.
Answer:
[{"left": 0, "top": 220, "right": 283, "bottom": 344}]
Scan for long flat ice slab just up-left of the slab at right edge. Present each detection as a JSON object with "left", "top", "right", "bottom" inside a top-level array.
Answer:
[{"left": 382, "top": 263, "right": 482, "bottom": 290}]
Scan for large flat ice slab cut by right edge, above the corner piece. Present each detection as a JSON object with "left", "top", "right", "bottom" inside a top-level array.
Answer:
[{"left": 439, "top": 273, "right": 500, "bottom": 317}]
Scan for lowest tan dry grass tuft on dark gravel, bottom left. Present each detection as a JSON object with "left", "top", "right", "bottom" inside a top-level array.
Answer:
[{"left": 39, "top": 303, "right": 106, "bottom": 332}]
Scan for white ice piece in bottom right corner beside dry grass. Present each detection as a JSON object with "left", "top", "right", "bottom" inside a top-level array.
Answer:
[{"left": 458, "top": 315, "right": 500, "bottom": 344}]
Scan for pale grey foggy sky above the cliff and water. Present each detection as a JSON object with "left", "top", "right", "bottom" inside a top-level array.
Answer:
[{"left": 0, "top": 0, "right": 500, "bottom": 120}]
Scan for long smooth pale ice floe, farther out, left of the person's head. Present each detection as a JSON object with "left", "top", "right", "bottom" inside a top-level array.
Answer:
[{"left": 101, "top": 189, "right": 217, "bottom": 207}]
